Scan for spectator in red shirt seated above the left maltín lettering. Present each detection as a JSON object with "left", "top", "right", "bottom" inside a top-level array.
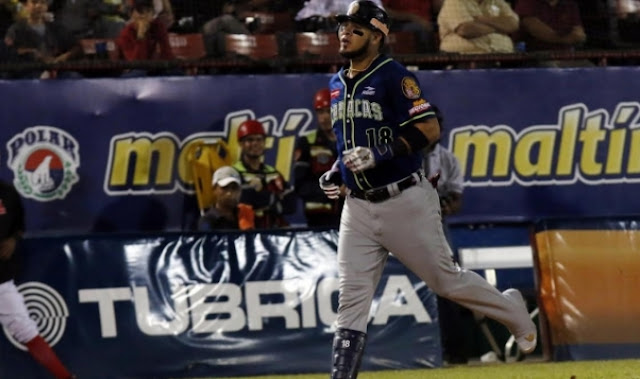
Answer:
[{"left": 116, "top": 0, "right": 175, "bottom": 75}]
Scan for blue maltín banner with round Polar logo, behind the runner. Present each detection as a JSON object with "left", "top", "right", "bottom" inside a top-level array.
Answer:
[{"left": 0, "top": 67, "right": 640, "bottom": 233}]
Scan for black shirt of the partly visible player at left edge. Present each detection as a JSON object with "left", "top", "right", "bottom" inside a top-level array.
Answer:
[{"left": 0, "top": 180, "right": 25, "bottom": 283}]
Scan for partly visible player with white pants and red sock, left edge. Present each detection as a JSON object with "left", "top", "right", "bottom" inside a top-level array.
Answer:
[{"left": 0, "top": 181, "right": 73, "bottom": 379}]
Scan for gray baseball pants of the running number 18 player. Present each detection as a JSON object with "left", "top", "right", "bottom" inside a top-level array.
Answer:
[{"left": 337, "top": 179, "right": 535, "bottom": 335}]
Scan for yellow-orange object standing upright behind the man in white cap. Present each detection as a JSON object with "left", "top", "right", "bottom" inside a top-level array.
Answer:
[{"left": 187, "top": 139, "right": 231, "bottom": 214}]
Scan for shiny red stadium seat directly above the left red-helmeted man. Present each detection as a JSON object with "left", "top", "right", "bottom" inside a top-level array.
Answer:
[{"left": 225, "top": 34, "right": 278, "bottom": 60}]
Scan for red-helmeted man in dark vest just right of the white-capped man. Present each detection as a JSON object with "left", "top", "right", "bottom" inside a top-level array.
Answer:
[{"left": 233, "top": 120, "right": 296, "bottom": 228}]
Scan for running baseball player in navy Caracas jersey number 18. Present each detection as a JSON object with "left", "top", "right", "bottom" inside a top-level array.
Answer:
[{"left": 320, "top": 0, "right": 537, "bottom": 379}]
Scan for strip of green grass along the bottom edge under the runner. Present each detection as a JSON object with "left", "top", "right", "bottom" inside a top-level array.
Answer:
[{"left": 214, "top": 359, "right": 640, "bottom": 379}]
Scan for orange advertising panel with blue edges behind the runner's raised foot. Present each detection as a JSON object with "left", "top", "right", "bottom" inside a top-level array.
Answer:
[{"left": 535, "top": 217, "right": 640, "bottom": 360}]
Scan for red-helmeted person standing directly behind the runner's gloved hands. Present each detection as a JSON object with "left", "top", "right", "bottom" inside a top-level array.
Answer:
[{"left": 294, "top": 88, "right": 344, "bottom": 228}]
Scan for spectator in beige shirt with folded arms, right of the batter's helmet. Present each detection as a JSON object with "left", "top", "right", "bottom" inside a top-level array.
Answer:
[{"left": 438, "top": 0, "right": 519, "bottom": 54}]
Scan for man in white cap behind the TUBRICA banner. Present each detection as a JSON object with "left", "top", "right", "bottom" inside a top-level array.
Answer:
[{"left": 198, "top": 166, "right": 255, "bottom": 231}]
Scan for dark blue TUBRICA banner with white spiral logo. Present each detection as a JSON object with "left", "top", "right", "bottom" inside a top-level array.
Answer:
[{"left": 0, "top": 230, "right": 442, "bottom": 379}]
